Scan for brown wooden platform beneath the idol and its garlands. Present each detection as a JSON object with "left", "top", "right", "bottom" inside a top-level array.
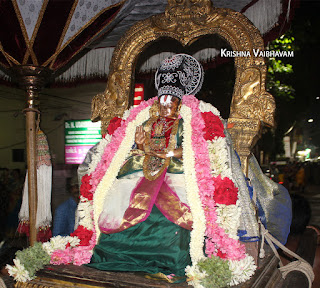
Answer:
[{"left": 11, "top": 246, "right": 281, "bottom": 288}]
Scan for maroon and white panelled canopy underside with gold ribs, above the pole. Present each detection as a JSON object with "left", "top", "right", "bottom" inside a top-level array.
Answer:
[{"left": 0, "top": 0, "right": 124, "bottom": 71}]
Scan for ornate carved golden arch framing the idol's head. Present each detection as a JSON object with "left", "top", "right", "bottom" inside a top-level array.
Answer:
[{"left": 91, "top": 0, "right": 275, "bottom": 172}]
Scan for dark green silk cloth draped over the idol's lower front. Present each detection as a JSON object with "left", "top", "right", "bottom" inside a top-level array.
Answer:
[{"left": 88, "top": 205, "right": 191, "bottom": 282}]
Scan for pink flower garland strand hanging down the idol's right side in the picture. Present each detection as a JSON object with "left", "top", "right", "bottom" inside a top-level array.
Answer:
[{"left": 182, "top": 95, "right": 246, "bottom": 260}]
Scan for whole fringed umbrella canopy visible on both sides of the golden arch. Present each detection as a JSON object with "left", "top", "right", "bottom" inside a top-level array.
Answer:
[{"left": 0, "top": 0, "right": 297, "bottom": 80}]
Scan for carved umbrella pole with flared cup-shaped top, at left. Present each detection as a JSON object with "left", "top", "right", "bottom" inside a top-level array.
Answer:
[{"left": 11, "top": 65, "right": 51, "bottom": 245}]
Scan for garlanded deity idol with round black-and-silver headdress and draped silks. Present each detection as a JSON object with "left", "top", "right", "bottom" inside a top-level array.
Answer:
[{"left": 9, "top": 54, "right": 291, "bottom": 288}]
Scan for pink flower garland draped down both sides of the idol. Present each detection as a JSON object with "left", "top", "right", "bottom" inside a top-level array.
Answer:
[{"left": 51, "top": 95, "right": 245, "bottom": 265}]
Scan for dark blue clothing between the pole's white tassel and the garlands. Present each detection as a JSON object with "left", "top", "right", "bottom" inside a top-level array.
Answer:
[{"left": 52, "top": 197, "right": 78, "bottom": 236}]
